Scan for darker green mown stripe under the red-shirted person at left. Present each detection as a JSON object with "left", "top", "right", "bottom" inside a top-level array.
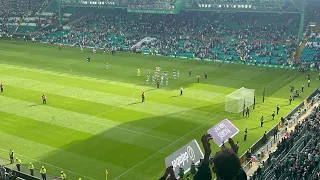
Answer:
[{"left": 2, "top": 86, "right": 212, "bottom": 139}]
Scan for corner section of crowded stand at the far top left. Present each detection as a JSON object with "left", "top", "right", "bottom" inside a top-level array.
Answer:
[{"left": 0, "top": 0, "right": 78, "bottom": 36}]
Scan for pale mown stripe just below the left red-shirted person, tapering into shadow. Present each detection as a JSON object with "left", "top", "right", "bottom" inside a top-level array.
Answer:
[{"left": 0, "top": 96, "right": 174, "bottom": 148}]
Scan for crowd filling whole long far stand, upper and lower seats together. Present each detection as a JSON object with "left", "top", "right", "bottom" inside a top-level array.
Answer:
[{"left": 42, "top": 10, "right": 297, "bottom": 65}]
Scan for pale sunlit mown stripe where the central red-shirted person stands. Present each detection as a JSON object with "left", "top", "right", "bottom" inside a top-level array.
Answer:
[{"left": 3, "top": 75, "right": 225, "bottom": 119}]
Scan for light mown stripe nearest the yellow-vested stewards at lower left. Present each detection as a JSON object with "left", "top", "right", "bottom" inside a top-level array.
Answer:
[{"left": 0, "top": 129, "right": 126, "bottom": 179}]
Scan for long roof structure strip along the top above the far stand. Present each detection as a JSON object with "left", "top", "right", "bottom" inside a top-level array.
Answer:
[{"left": 61, "top": 0, "right": 312, "bottom": 13}]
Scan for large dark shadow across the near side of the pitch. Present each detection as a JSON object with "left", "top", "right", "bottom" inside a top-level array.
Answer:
[{"left": 34, "top": 102, "right": 230, "bottom": 179}]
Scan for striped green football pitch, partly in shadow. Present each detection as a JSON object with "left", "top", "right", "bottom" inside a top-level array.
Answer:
[{"left": 0, "top": 41, "right": 319, "bottom": 180}]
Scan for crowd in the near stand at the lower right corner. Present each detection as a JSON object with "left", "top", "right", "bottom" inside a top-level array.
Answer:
[{"left": 250, "top": 106, "right": 320, "bottom": 180}]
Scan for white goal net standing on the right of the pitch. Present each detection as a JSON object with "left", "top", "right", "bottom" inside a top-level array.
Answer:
[{"left": 225, "top": 87, "right": 255, "bottom": 113}]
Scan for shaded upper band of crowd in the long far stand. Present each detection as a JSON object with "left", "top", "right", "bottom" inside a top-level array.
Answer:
[{"left": 67, "top": 10, "right": 297, "bottom": 41}]
